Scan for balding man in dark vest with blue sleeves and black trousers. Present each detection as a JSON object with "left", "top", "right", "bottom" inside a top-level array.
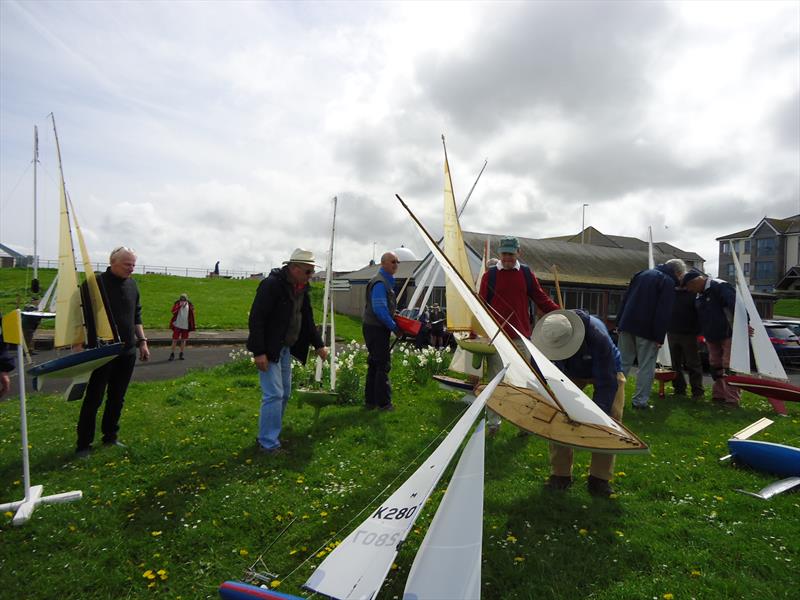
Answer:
[{"left": 361, "top": 252, "right": 400, "bottom": 410}]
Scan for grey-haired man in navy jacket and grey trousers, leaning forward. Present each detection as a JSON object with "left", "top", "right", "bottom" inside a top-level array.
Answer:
[{"left": 617, "top": 258, "right": 686, "bottom": 409}]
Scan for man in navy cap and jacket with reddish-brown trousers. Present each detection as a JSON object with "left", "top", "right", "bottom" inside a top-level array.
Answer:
[{"left": 683, "top": 269, "right": 739, "bottom": 406}]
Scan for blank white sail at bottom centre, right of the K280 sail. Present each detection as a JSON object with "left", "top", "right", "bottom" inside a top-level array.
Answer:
[{"left": 403, "top": 419, "right": 486, "bottom": 600}]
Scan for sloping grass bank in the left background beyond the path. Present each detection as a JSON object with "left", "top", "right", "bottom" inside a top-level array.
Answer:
[{"left": 0, "top": 268, "right": 363, "bottom": 340}]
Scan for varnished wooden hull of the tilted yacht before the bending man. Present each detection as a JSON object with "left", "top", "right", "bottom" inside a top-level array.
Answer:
[{"left": 479, "top": 384, "right": 649, "bottom": 454}]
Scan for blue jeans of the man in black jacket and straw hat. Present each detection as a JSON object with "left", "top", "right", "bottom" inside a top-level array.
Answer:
[{"left": 258, "top": 346, "right": 292, "bottom": 450}]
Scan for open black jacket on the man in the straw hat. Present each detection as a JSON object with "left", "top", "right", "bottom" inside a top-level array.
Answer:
[{"left": 247, "top": 267, "right": 325, "bottom": 364}]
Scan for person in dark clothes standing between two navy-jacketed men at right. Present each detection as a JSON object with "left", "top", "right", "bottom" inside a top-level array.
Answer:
[{"left": 667, "top": 287, "right": 704, "bottom": 400}]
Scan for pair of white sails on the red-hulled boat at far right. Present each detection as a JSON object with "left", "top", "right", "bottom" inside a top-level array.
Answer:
[{"left": 730, "top": 252, "right": 788, "bottom": 381}]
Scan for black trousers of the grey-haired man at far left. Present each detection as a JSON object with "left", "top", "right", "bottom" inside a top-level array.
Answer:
[{"left": 77, "top": 352, "right": 136, "bottom": 450}]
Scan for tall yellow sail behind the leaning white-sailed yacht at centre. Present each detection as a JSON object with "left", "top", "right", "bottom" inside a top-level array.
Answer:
[{"left": 444, "top": 155, "right": 474, "bottom": 331}]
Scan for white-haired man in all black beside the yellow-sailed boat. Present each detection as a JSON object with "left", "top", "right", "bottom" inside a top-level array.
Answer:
[{"left": 75, "top": 246, "right": 150, "bottom": 456}]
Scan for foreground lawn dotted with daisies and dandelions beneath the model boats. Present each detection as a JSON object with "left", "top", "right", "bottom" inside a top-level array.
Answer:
[{"left": 0, "top": 350, "right": 800, "bottom": 600}]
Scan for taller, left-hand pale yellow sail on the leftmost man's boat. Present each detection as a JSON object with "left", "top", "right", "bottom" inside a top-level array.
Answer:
[{"left": 53, "top": 176, "right": 85, "bottom": 348}]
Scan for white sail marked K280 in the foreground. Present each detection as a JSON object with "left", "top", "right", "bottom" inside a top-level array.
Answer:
[{"left": 303, "top": 369, "right": 506, "bottom": 600}]
